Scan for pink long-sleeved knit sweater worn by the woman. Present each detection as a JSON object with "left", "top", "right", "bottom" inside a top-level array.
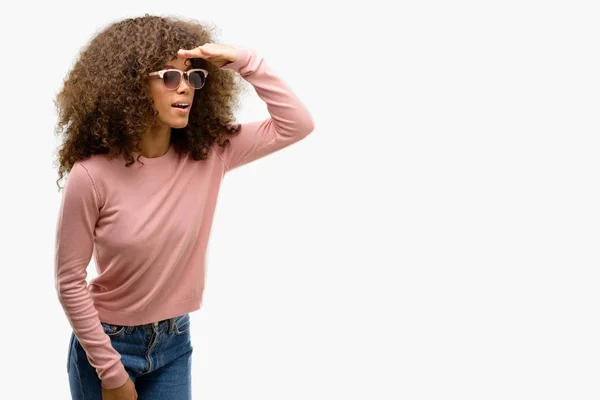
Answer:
[{"left": 55, "top": 46, "right": 314, "bottom": 388}]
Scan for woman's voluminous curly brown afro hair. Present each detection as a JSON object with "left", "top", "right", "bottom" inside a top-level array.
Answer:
[{"left": 55, "top": 14, "right": 243, "bottom": 191}]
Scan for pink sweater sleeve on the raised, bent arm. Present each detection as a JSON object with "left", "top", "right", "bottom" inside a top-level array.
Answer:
[{"left": 217, "top": 46, "right": 314, "bottom": 171}]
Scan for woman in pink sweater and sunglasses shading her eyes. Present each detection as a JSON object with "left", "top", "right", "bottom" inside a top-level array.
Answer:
[{"left": 55, "top": 15, "right": 314, "bottom": 400}]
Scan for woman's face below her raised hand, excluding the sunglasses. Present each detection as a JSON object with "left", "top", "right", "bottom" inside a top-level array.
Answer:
[{"left": 149, "top": 57, "right": 195, "bottom": 129}]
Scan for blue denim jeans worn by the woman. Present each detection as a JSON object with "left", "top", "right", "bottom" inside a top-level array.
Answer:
[{"left": 67, "top": 314, "right": 192, "bottom": 400}]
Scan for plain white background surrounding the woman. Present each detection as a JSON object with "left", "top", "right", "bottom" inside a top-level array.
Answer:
[{"left": 0, "top": 0, "right": 600, "bottom": 400}]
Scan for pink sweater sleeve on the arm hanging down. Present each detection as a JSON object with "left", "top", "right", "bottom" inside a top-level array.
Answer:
[{"left": 54, "top": 162, "right": 129, "bottom": 389}]
